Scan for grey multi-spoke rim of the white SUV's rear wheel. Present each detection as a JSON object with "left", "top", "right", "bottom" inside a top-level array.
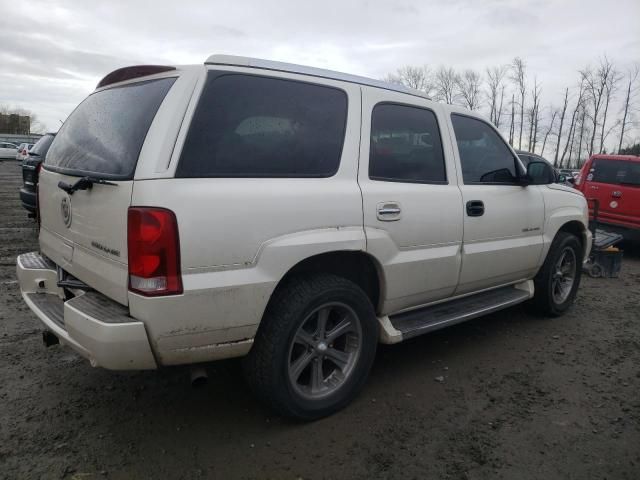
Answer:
[{"left": 287, "top": 302, "right": 362, "bottom": 400}]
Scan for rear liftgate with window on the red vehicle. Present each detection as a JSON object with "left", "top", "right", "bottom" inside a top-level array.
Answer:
[{"left": 584, "top": 157, "right": 640, "bottom": 228}]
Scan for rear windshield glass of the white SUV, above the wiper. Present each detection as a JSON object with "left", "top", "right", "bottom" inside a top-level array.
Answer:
[{"left": 45, "top": 78, "right": 175, "bottom": 179}]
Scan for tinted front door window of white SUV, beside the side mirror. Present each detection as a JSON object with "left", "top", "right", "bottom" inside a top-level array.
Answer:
[{"left": 451, "top": 114, "right": 518, "bottom": 184}]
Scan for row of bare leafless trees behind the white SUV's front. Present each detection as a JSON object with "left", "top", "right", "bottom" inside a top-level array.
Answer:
[{"left": 384, "top": 55, "right": 640, "bottom": 168}]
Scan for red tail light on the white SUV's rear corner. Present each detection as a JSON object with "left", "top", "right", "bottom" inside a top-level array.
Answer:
[{"left": 127, "top": 207, "right": 182, "bottom": 296}]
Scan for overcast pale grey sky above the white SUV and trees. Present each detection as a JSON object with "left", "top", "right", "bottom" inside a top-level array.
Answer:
[{"left": 0, "top": 0, "right": 640, "bottom": 147}]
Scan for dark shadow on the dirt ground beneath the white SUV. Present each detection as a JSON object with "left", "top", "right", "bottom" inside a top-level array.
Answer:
[{"left": 35, "top": 307, "right": 536, "bottom": 430}]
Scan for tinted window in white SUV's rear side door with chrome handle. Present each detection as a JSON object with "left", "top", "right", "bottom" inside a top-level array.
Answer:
[{"left": 369, "top": 103, "right": 447, "bottom": 183}]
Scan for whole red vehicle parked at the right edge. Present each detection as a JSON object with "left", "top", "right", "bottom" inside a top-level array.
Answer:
[{"left": 575, "top": 155, "right": 640, "bottom": 240}]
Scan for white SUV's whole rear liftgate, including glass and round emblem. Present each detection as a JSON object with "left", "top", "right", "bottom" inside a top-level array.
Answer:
[{"left": 39, "top": 77, "right": 176, "bottom": 304}]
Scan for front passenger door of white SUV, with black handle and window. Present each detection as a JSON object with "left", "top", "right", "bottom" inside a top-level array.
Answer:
[{"left": 444, "top": 113, "right": 544, "bottom": 294}]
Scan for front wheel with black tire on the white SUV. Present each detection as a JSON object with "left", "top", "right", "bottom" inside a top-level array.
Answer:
[{"left": 533, "top": 232, "right": 583, "bottom": 317}]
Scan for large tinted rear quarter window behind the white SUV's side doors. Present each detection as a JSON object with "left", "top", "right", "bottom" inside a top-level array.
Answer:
[{"left": 176, "top": 72, "right": 347, "bottom": 177}]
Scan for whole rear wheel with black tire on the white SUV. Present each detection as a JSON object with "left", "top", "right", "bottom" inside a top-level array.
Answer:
[{"left": 244, "top": 274, "right": 378, "bottom": 420}]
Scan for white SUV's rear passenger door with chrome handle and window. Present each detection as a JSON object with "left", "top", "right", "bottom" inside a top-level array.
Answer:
[{"left": 358, "top": 87, "right": 462, "bottom": 313}]
